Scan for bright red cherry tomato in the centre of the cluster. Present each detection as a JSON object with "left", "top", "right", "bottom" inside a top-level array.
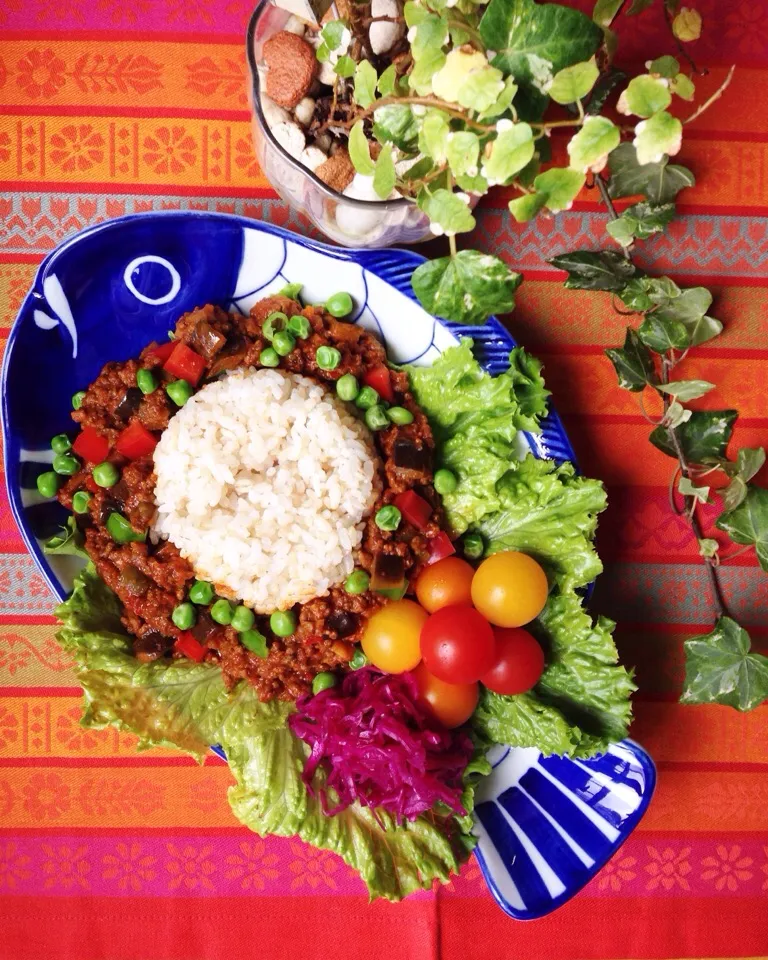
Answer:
[{"left": 421, "top": 605, "right": 495, "bottom": 683}]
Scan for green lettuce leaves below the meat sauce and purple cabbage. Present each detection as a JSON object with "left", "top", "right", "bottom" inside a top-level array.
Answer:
[{"left": 56, "top": 565, "right": 472, "bottom": 900}]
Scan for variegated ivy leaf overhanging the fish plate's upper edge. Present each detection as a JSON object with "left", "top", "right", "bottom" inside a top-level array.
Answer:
[{"left": 412, "top": 250, "right": 522, "bottom": 324}]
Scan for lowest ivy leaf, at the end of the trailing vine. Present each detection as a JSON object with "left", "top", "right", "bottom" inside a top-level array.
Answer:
[{"left": 680, "top": 617, "right": 768, "bottom": 711}]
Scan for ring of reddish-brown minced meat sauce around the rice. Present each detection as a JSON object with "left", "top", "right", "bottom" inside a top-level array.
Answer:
[{"left": 58, "top": 295, "right": 452, "bottom": 700}]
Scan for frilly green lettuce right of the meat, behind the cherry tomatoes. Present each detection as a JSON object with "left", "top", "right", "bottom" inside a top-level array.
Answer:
[{"left": 408, "top": 339, "right": 635, "bottom": 756}]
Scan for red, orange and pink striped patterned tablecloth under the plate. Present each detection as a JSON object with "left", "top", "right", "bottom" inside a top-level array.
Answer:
[{"left": 0, "top": 0, "right": 768, "bottom": 960}]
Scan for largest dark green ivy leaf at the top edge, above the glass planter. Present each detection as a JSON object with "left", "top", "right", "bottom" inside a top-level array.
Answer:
[{"left": 480, "top": 0, "right": 603, "bottom": 110}]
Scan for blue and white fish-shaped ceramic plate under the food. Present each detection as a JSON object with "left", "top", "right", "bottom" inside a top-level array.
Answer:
[{"left": 2, "top": 212, "right": 655, "bottom": 919}]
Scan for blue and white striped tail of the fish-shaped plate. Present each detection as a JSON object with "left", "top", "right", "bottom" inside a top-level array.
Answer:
[{"left": 473, "top": 740, "right": 656, "bottom": 920}]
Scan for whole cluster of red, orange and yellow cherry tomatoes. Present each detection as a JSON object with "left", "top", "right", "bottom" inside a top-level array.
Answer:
[{"left": 362, "top": 551, "right": 547, "bottom": 727}]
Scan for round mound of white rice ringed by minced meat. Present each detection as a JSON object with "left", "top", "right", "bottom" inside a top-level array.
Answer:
[{"left": 153, "top": 370, "right": 380, "bottom": 613}]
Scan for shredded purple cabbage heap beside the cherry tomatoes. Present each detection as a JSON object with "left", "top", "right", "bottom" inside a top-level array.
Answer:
[{"left": 288, "top": 667, "right": 473, "bottom": 820}]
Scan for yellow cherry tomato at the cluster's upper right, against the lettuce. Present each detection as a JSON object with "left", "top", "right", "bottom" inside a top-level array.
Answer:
[{"left": 472, "top": 550, "right": 548, "bottom": 627}]
